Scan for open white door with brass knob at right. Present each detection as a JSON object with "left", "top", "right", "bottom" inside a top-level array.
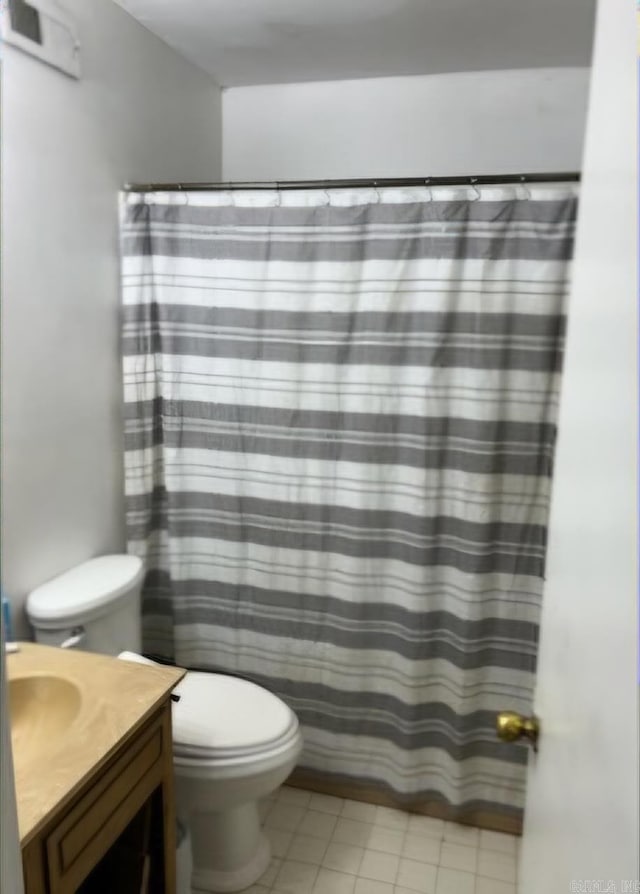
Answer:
[{"left": 516, "top": 0, "right": 640, "bottom": 894}]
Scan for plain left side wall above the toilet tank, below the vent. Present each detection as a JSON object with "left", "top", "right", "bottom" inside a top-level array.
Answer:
[{"left": 2, "top": 0, "right": 221, "bottom": 635}]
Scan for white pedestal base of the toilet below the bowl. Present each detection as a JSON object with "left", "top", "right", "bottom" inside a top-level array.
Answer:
[{"left": 189, "top": 802, "right": 271, "bottom": 894}]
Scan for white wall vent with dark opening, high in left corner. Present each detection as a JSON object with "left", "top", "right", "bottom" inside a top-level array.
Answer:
[{"left": 0, "top": 0, "right": 80, "bottom": 78}]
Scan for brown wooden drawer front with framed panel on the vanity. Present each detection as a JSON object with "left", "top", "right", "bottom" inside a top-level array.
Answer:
[{"left": 46, "top": 712, "right": 171, "bottom": 894}]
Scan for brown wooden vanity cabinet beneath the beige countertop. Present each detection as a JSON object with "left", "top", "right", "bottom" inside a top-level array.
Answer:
[{"left": 22, "top": 697, "right": 176, "bottom": 894}]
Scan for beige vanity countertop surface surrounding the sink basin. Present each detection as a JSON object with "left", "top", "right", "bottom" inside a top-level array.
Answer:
[{"left": 6, "top": 643, "right": 186, "bottom": 847}]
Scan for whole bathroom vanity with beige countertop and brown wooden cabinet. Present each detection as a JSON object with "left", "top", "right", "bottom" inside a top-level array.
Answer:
[{"left": 8, "top": 643, "right": 185, "bottom": 894}]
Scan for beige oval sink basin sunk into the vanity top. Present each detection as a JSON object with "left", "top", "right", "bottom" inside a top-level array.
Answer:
[{"left": 9, "top": 674, "right": 82, "bottom": 760}]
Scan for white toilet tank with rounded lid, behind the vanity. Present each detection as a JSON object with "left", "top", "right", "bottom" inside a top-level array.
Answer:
[{"left": 26, "top": 555, "right": 143, "bottom": 655}]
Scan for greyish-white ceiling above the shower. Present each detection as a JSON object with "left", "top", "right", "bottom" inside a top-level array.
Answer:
[{"left": 116, "top": 0, "right": 595, "bottom": 87}]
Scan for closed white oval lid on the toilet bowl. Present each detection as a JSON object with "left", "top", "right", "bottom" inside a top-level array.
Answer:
[{"left": 172, "top": 672, "right": 296, "bottom": 756}]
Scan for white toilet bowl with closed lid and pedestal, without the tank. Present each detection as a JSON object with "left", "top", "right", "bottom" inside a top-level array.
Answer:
[{"left": 127, "top": 653, "right": 302, "bottom": 894}]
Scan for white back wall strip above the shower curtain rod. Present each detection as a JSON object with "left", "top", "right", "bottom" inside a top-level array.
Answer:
[{"left": 222, "top": 68, "right": 589, "bottom": 180}]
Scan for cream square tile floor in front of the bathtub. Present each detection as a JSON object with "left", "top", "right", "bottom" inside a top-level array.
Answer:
[{"left": 242, "top": 786, "right": 518, "bottom": 894}]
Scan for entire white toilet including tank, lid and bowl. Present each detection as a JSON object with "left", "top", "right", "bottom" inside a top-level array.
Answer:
[{"left": 26, "top": 555, "right": 302, "bottom": 894}]
